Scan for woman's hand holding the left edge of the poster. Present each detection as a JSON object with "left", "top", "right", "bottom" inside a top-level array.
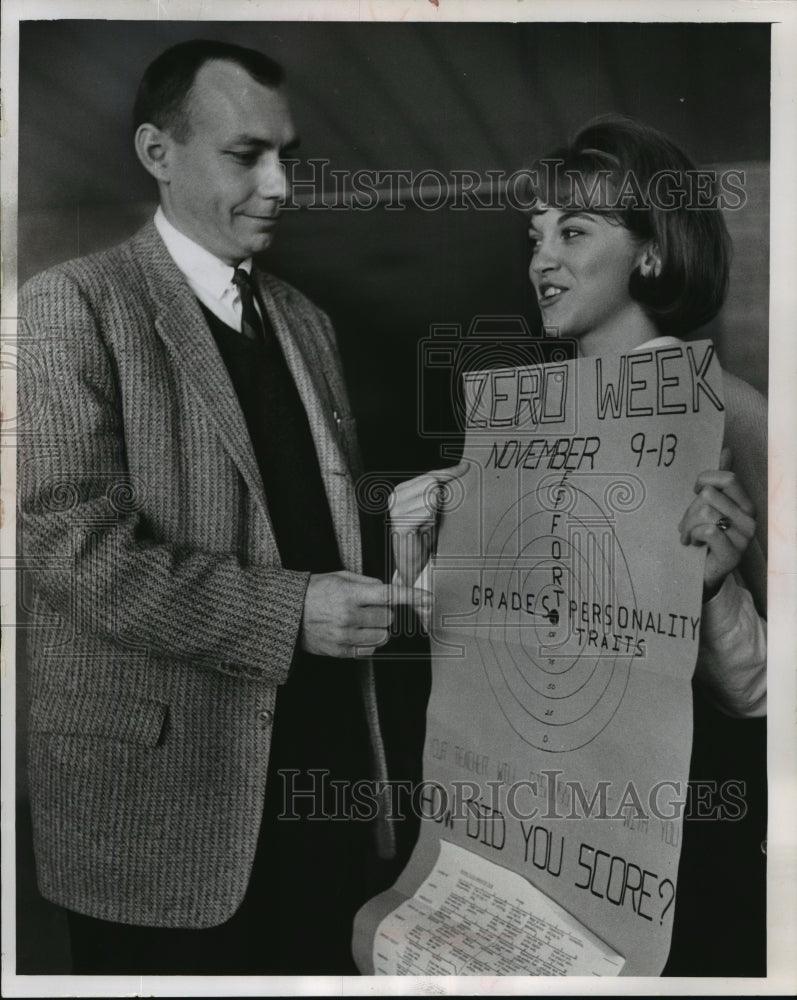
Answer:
[{"left": 390, "top": 462, "right": 468, "bottom": 586}]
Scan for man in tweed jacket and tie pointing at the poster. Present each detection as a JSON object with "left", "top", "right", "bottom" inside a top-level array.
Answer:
[{"left": 20, "top": 41, "right": 420, "bottom": 974}]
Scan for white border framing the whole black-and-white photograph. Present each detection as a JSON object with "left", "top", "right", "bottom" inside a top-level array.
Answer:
[{"left": 0, "top": 0, "right": 797, "bottom": 997}]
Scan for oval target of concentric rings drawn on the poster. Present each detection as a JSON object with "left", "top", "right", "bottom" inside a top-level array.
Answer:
[{"left": 473, "top": 483, "right": 638, "bottom": 753}]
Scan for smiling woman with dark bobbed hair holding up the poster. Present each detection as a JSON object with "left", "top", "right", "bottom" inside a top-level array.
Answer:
[{"left": 391, "top": 116, "right": 767, "bottom": 975}]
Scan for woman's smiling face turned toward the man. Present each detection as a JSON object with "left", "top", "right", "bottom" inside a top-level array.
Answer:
[{"left": 529, "top": 206, "right": 655, "bottom": 349}]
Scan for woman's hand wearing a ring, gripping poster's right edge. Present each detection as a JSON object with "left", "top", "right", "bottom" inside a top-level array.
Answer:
[{"left": 678, "top": 448, "right": 756, "bottom": 601}]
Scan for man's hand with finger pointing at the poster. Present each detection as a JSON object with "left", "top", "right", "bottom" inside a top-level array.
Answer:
[{"left": 300, "top": 571, "right": 432, "bottom": 658}]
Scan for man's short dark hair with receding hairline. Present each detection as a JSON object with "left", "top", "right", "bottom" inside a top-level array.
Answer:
[{"left": 133, "top": 38, "right": 285, "bottom": 142}]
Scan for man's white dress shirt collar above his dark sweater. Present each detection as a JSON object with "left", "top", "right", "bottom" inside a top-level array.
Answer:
[{"left": 154, "top": 206, "right": 260, "bottom": 332}]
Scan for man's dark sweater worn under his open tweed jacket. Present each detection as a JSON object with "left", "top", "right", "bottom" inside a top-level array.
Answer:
[{"left": 202, "top": 306, "right": 370, "bottom": 792}]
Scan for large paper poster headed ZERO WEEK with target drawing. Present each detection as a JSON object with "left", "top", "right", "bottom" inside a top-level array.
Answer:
[{"left": 354, "top": 341, "right": 724, "bottom": 975}]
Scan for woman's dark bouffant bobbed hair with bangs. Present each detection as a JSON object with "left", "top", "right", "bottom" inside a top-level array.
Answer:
[{"left": 531, "top": 115, "right": 730, "bottom": 335}]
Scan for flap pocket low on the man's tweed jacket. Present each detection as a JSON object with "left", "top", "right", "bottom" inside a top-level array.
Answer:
[{"left": 30, "top": 689, "right": 168, "bottom": 747}]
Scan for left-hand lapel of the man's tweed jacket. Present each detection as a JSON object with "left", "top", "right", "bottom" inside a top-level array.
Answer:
[{"left": 133, "top": 223, "right": 273, "bottom": 537}]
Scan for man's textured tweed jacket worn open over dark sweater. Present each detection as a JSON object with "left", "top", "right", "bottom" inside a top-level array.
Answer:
[{"left": 19, "top": 223, "right": 392, "bottom": 927}]
